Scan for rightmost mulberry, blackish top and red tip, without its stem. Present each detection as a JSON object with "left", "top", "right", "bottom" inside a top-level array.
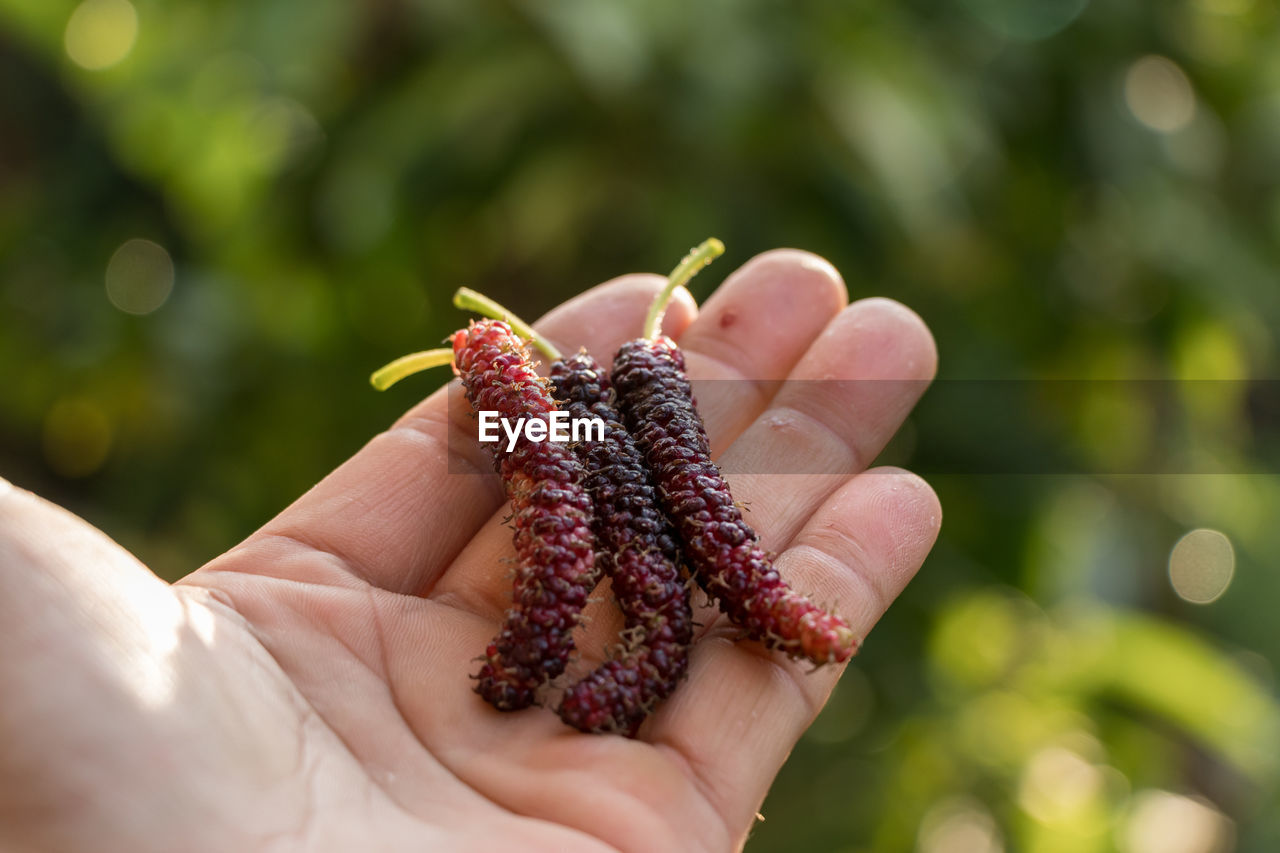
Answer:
[{"left": 613, "top": 338, "right": 858, "bottom": 665}]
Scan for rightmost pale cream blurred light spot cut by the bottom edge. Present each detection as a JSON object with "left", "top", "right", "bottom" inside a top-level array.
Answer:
[{"left": 1123, "top": 790, "right": 1235, "bottom": 853}]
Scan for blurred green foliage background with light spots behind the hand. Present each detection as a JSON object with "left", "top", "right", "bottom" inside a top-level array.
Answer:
[{"left": 0, "top": 0, "right": 1280, "bottom": 853}]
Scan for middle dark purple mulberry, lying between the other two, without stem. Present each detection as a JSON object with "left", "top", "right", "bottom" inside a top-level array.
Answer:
[{"left": 550, "top": 352, "right": 694, "bottom": 736}]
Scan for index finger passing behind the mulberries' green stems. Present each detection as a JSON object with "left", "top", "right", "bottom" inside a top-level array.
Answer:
[{"left": 205, "top": 275, "right": 696, "bottom": 592}]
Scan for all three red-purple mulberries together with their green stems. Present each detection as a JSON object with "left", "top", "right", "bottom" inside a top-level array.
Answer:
[{"left": 374, "top": 240, "right": 858, "bottom": 736}]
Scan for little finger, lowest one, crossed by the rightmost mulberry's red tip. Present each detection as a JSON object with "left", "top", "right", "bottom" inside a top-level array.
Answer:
[{"left": 645, "top": 469, "right": 942, "bottom": 831}]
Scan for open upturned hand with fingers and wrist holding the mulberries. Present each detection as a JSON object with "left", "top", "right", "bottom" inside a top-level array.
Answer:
[{"left": 0, "top": 251, "right": 941, "bottom": 852}]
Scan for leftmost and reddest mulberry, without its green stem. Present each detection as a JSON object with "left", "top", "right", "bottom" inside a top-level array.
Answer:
[{"left": 453, "top": 320, "right": 599, "bottom": 711}]
